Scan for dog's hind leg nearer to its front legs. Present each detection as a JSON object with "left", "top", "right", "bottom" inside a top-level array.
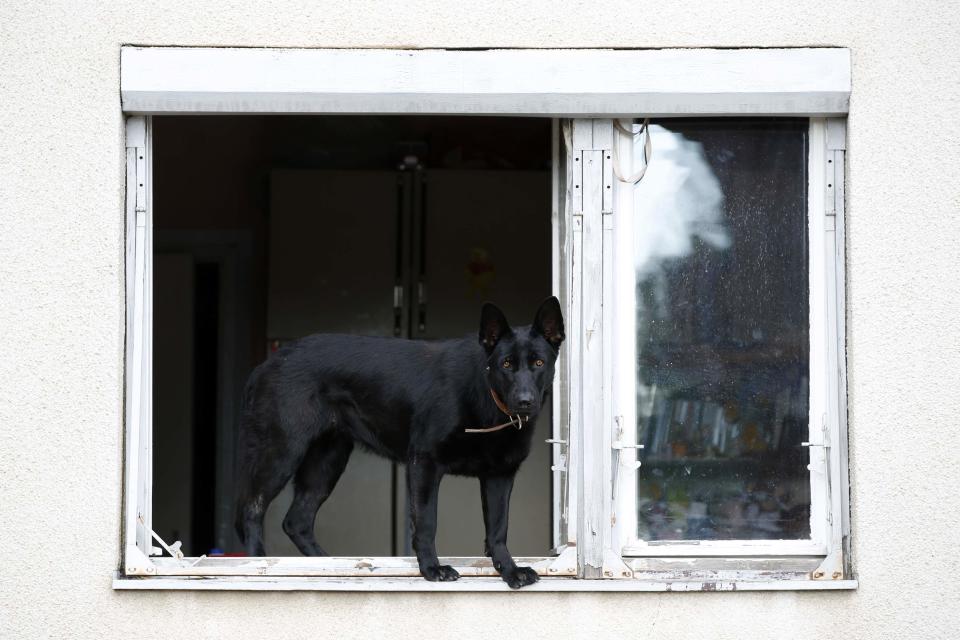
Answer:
[{"left": 283, "top": 433, "right": 353, "bottom": 556}]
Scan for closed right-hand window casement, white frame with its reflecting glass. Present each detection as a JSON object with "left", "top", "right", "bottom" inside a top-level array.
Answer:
[{"left": 614, "top": 118, "right": 849, "bottom": 579}]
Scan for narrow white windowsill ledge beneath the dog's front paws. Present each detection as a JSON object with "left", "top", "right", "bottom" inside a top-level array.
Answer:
[{"left": 113, "top": 573, "right": 858, "bottom": 593}]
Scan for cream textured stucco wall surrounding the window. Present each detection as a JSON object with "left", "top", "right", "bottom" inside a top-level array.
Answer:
[{"left": 0, "top": 0, "right": 960, "bottom": 638}]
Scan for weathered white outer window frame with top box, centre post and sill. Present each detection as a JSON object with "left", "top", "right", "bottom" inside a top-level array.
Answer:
[{"left": 114, "top": 47, "right": 856, "bottom": 591}]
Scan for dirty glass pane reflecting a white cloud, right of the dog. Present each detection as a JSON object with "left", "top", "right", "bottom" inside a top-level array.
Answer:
[{"left": 634, "top": 119, "right": 810, "bottom": 540}]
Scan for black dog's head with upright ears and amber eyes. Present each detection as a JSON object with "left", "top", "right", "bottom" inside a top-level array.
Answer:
[{"left": 480, "top": 297, "right": 564, "bottom": 418}]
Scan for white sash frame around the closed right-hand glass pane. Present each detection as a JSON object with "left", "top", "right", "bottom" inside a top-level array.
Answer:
[{"left": 605, "top": 118, "right": 849, "bottom": 580}]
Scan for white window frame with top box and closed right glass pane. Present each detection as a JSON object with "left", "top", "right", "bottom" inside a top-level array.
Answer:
[{"left": 115, "top": 48, "right": 855, "bottom": 590}]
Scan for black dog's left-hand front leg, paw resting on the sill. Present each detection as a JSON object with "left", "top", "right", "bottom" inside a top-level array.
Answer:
[{"left": 407, "top": 455, "right": 460, "bottom": 582}]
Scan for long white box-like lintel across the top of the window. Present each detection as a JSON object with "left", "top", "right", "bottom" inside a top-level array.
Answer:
[{"left": 120, "top": 46, "right": 851, "bottom": 117}]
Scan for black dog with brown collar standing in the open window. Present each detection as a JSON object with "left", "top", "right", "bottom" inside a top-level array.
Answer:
[{"left": 236, "top": 298, "right": 564, "bottom": 588}]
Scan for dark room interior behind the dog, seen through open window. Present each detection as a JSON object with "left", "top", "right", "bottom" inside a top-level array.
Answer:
[{"left": 153, "top": 116, "right": 551, "bottom": 556}]
